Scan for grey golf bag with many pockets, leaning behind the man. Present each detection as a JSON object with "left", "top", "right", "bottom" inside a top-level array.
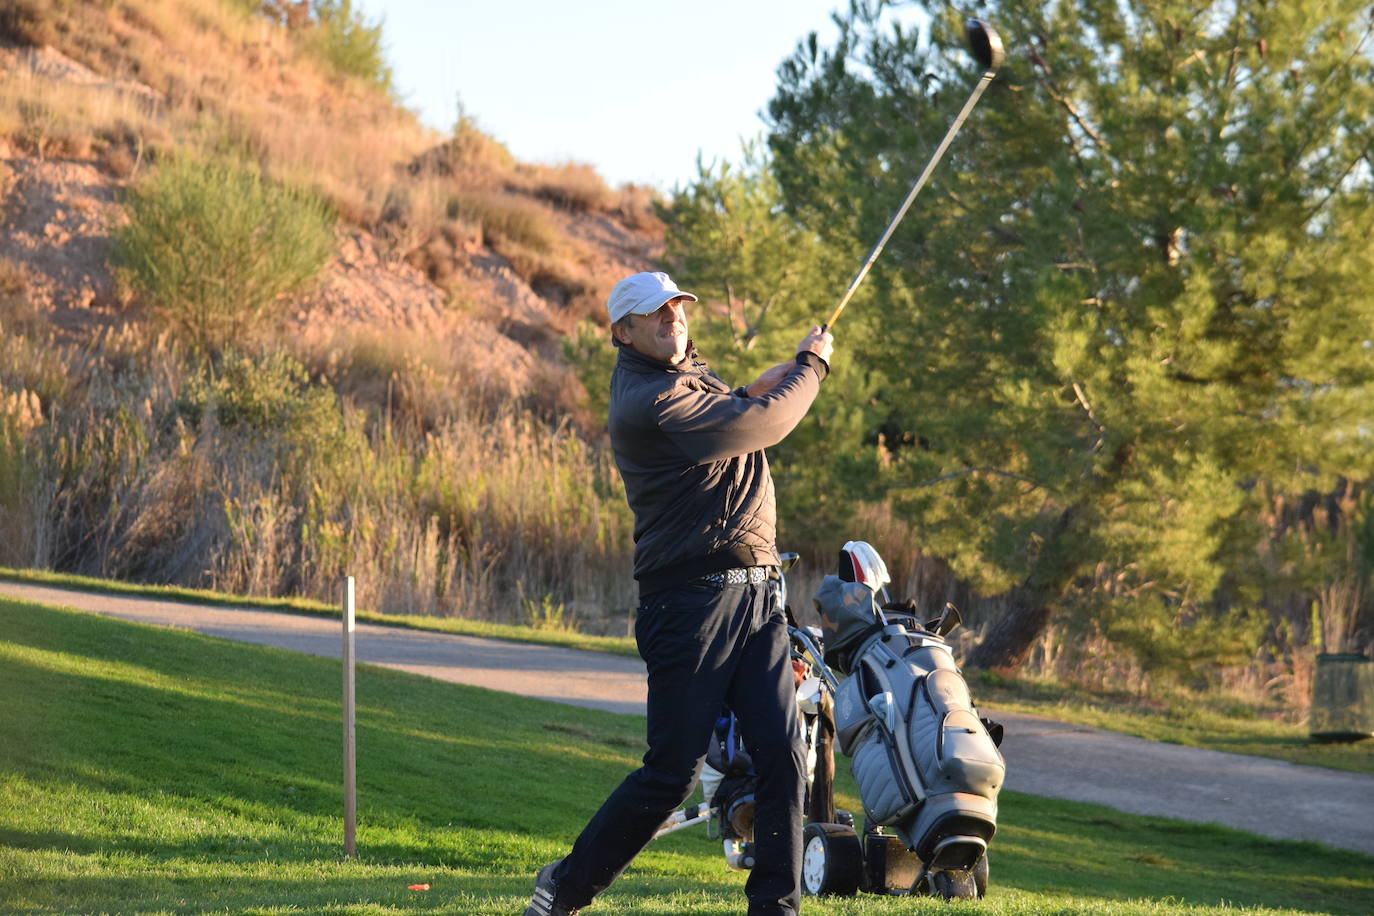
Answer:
[{"left": 815, "top": 568, "right": 1004, "bottom": 883}]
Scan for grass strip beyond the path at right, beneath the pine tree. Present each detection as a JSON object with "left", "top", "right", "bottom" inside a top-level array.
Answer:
[{"left": 973, "top": 678, "right": 1374, "bottom": 773}]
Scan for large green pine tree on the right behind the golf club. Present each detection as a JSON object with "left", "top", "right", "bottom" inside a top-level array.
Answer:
[{"left": 673, "top": 0, "right": 1374, "bottom": 666}]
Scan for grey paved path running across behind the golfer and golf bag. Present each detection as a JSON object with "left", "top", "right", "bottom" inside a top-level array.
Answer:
[{"left": 0, "top": 581, "right": 1374, "bottom": 854}]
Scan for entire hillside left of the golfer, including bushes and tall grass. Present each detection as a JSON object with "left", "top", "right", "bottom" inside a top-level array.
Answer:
[{"left": 0, "top": 0, "right": 664, "bottom": 633}]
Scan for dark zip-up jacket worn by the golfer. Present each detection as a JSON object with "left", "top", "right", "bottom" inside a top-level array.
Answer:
[{"left": 609, "top": 340, "right": 829, "bottom": 592}]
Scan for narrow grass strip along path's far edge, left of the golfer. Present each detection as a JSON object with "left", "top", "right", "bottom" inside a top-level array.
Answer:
[{"left": 0, "top": 566, "right": 639, "bottom": 658}]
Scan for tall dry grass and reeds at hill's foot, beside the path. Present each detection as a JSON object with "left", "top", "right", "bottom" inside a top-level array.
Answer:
[{"left": 0, "top": 317, "right": 635, "bottom": 632}]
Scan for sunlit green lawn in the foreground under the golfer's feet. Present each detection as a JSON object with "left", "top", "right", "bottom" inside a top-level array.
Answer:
[{"left": 0, "top": 600, "right": 1374, "bottom": 916}]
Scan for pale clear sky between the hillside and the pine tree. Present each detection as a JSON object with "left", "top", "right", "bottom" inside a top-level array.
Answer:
[{"left": 354, "top": 0, "right": 848, "bottom": 191}]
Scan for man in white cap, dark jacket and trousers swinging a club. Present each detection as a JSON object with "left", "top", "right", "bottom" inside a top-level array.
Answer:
[{"left": 525, "top": 273, "right": 831, "bottom": 916}]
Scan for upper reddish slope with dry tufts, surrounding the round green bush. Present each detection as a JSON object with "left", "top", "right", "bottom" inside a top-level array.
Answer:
[{"left": 0, "top": 0, "right": 661, "bottom": 376}]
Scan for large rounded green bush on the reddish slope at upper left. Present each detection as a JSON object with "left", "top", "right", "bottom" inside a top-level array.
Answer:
[{"left": 114, "top": 157, "right": 334, "bottom": 350}]
